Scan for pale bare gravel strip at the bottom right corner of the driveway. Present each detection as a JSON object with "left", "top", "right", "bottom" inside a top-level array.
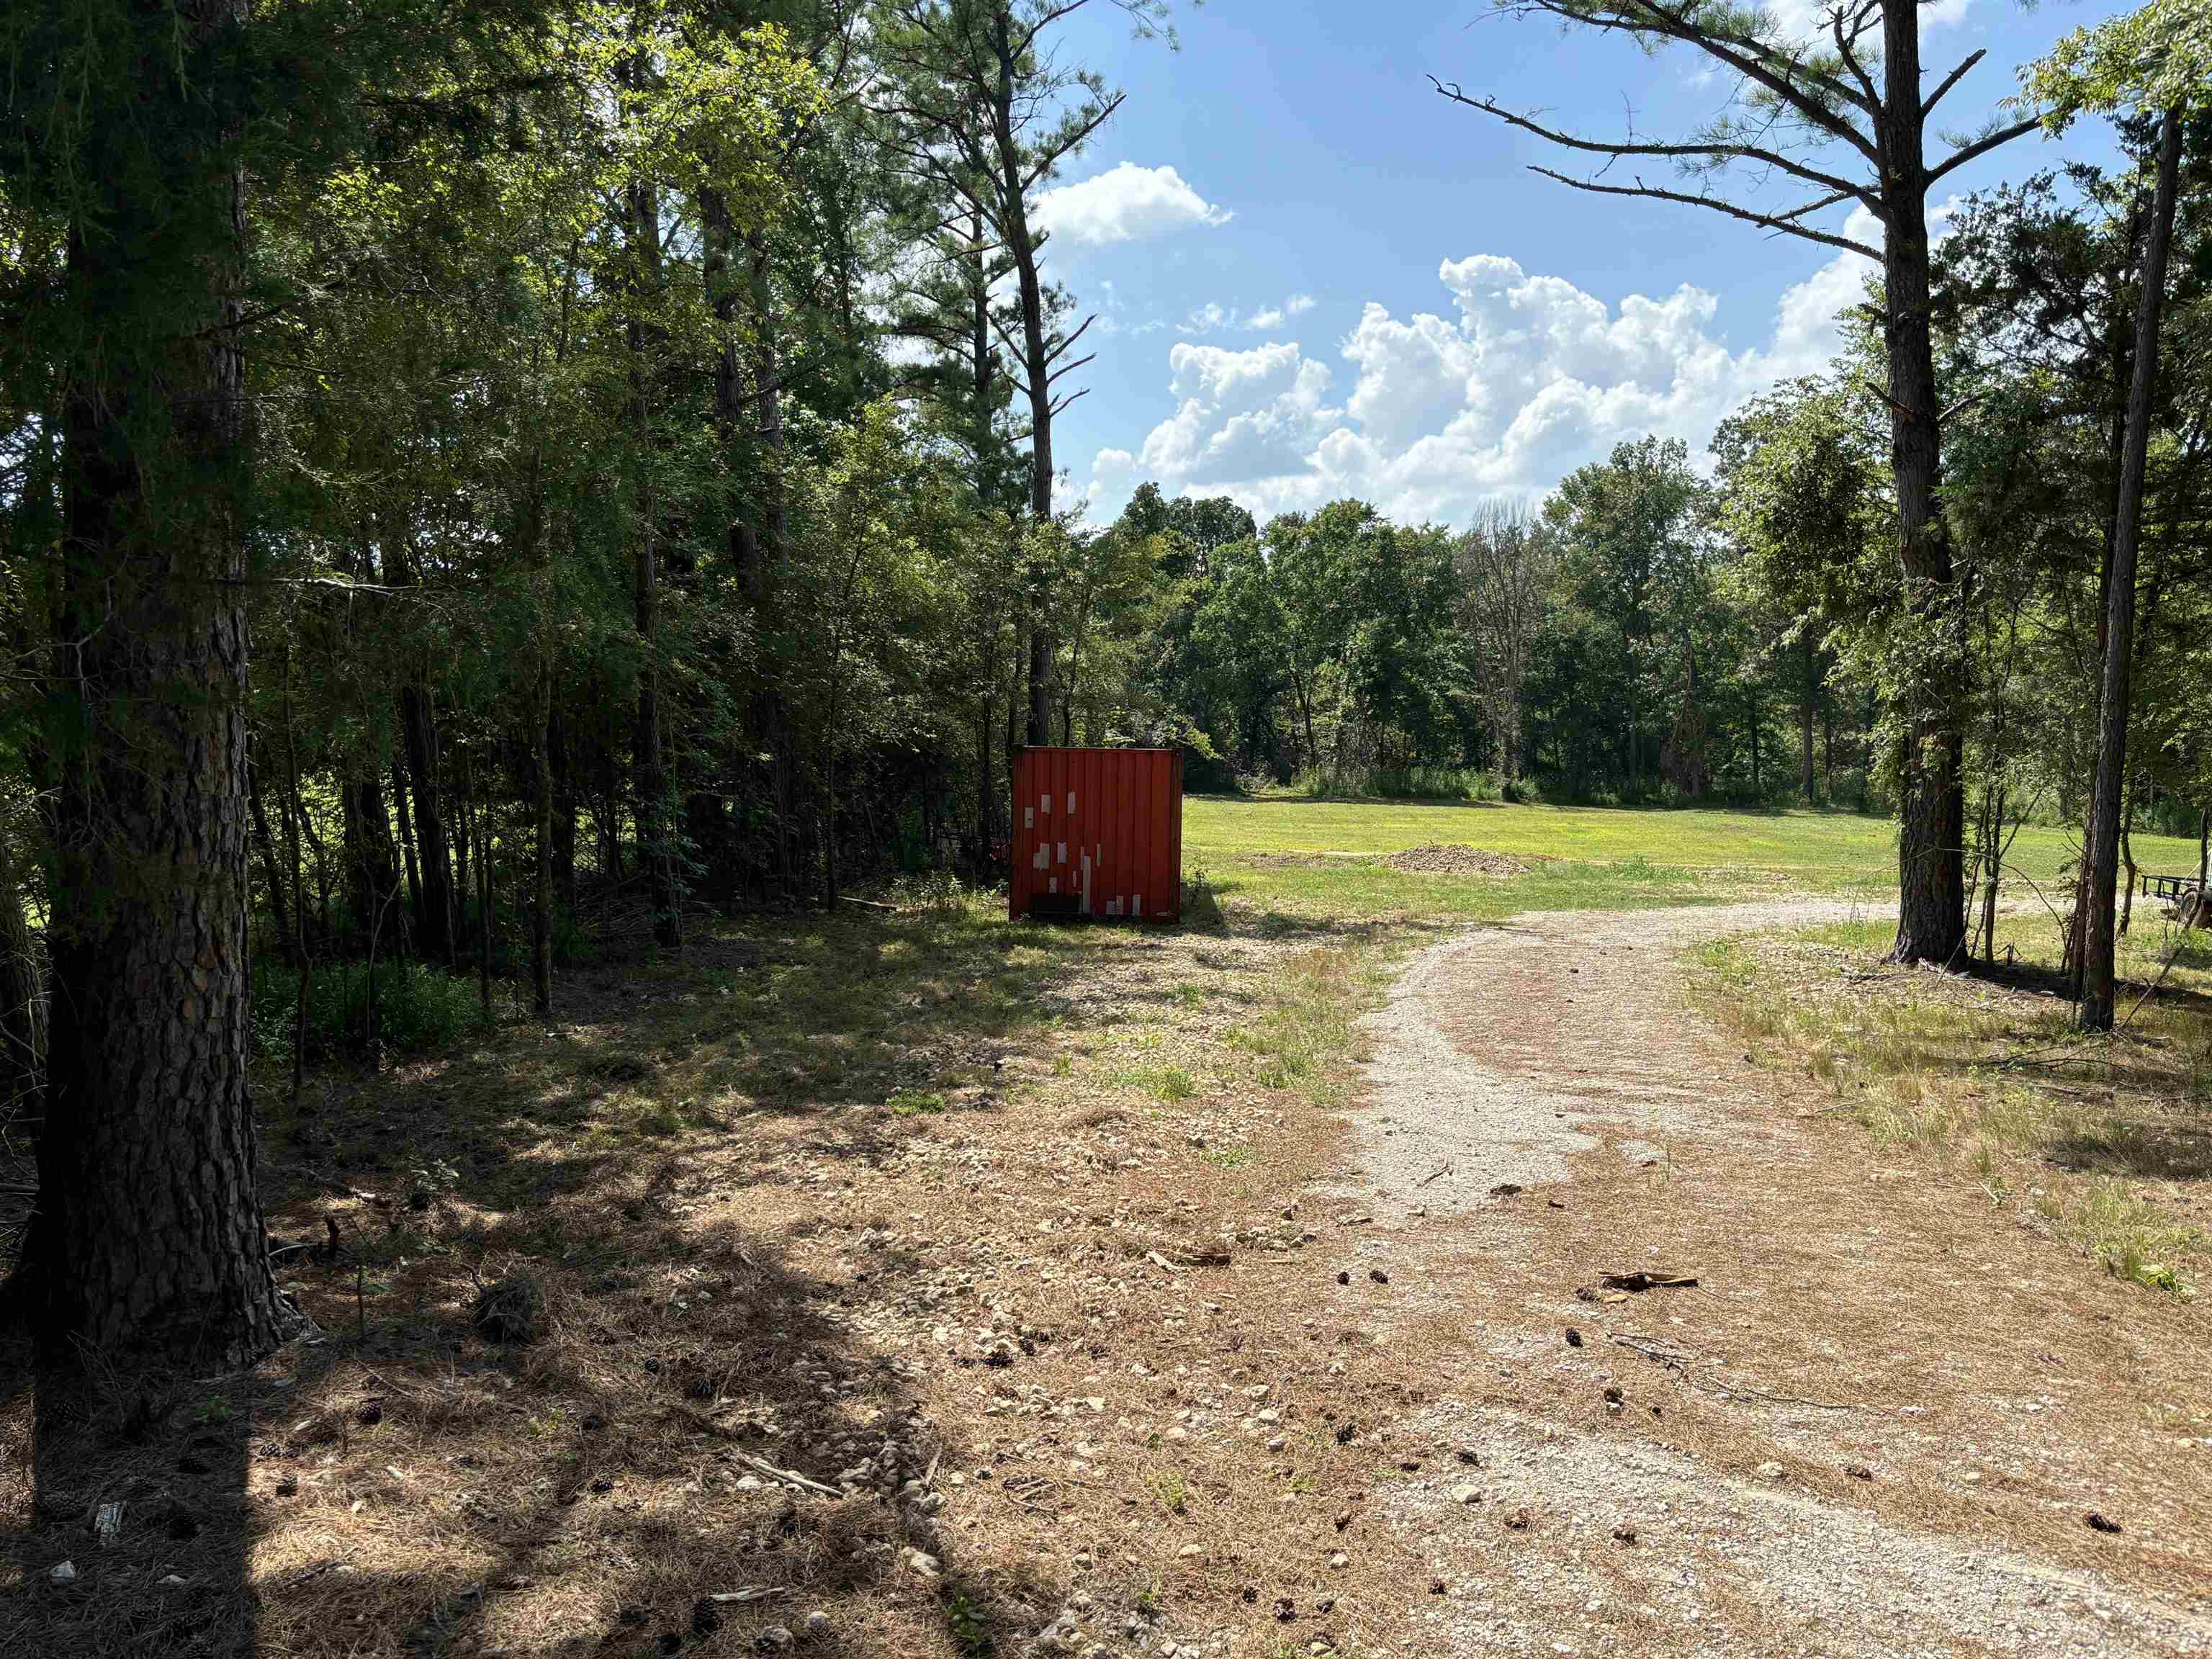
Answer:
[{"left": 1393, "top": 1401, "right": 2212, "bottom": 1659}]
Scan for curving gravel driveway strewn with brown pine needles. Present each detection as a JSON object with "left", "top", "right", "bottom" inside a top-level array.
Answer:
[{"left": 1336, "top": 904, "right": 2212, "bottom": 1657}]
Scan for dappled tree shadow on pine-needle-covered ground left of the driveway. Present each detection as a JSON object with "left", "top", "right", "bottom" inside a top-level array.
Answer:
[{"left": 0, "top": 898, "right": 1265, "bottom": 1659}]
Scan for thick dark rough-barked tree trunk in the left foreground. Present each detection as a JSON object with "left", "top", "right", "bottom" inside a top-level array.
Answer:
[{"left": 22, "top": 0, "right": 303, "bottom": 1367}]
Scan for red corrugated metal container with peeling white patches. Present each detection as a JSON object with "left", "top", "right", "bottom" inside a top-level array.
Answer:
[{"left": 1007, "top": 750, "right": 1184, "bottom": 922}]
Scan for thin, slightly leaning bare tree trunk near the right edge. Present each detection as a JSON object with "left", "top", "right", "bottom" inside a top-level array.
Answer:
[{"left": 2082, "top": 111, "right": 2181, "bottom": 1031}]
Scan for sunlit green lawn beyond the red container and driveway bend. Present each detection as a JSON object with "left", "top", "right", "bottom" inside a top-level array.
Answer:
[{"left": 1184, "top": 796, "right": 2196, "bottom": 916}]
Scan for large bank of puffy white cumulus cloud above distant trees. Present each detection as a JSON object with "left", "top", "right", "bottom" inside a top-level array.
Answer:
[{"left": 1088, "top": 240, "right": 1871, "bottom": 522}]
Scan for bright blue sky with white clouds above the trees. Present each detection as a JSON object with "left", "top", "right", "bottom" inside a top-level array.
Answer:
[{"left": 1046, "top": 0, "right": 2141, "bottom": 522}]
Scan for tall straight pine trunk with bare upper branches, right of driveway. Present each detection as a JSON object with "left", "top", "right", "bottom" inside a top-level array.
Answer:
[{"left": 1878, "top": 0, "right": 1966, "bottom": 962}]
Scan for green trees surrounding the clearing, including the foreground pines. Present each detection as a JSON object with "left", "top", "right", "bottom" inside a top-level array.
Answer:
[{"left": 0, "top": 0, "right": 2206, "bottom": 1358}]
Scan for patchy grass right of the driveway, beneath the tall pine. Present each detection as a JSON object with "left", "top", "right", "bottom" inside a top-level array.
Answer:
[{"left": 1692, "top": 912, "right": 2212, "bottom": 1296}]
